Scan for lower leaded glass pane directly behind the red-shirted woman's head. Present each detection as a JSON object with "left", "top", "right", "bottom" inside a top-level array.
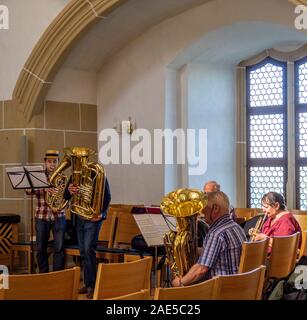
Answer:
[{"left": 249, "top": 167, "right": 284, "bottom": 208}]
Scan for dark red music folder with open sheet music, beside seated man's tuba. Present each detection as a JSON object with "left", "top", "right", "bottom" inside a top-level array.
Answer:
[{"left": 131, "top": 207, "right": 176, "bottom": 247}]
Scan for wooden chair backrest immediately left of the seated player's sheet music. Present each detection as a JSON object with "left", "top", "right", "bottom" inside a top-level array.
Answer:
[{"left": 114, "top": 208, "right": 141, "bottom": 248}]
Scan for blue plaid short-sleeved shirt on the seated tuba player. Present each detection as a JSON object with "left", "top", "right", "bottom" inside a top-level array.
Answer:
[{"left": 198, "top": 215, "right": 247, "bottom": 278}]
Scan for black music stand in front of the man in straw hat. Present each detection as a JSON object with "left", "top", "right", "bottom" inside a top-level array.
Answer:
[{"left": 5, "top": 166, "right": 52, "bottom": 272}]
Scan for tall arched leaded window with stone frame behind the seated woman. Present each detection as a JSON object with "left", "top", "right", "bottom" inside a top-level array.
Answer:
[{"left": 237, "top": 45, "right": 307, "bottom": 210}]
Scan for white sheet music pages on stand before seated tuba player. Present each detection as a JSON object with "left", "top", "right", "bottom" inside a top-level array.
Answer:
[{"left": 133, "top": 213, "right": 176, "bottom": 246}]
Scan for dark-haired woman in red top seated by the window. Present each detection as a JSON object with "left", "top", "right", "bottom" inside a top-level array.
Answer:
[{"left": 254, "top": 192, "right": 302, "bottom": 252}]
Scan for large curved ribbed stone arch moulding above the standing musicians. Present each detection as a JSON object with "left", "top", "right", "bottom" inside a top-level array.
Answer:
[{"left": 13, "top": 0, "right": 127, "bottom": 120}]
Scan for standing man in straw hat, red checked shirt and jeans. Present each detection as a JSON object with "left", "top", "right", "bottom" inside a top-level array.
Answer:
[{"left": 26, "top": 150, "right": 66, "bottom": 273}]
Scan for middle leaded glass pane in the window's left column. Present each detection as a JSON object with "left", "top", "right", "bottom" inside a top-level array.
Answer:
[{"left": 250, "top": 114, "right": 284, "bottom": 158}]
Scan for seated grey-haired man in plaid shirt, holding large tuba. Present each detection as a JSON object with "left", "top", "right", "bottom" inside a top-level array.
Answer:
[{"left": 173, "top": 191, "right": 246, "bottom": 287}]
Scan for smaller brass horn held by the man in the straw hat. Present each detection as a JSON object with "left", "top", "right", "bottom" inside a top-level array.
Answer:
[{"left": 45, "top": 157, "right": 69, "bottom": 212}]
